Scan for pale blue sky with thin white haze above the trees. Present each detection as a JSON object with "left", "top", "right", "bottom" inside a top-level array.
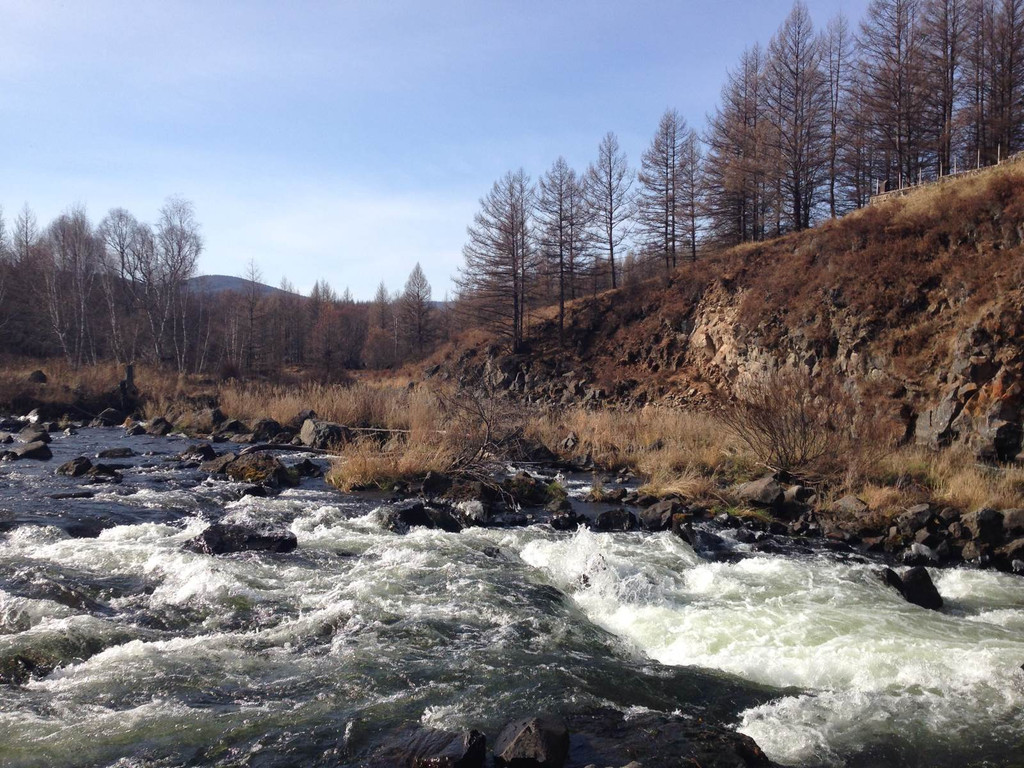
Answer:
[{"left": 0, "top": 0, "right": 867, "bottom": 298}]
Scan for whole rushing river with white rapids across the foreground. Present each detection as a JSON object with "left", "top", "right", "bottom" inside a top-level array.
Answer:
[{"left": 0, "top": 428, "right": 1024, "bottom": 768}]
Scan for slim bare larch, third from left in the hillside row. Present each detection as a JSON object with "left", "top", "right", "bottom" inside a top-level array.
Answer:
[{"left": 587, "top": 131, "right": 634, "bottom": 288}]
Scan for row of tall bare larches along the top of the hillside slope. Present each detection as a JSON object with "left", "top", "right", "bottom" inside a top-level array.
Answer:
[{"left": 457, "top": 0, "right": 1024, "bottom": 349}]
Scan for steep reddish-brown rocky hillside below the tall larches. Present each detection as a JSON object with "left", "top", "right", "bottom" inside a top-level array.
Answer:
[{"left": 438, "top": 163, "right": 1024, "bottom": 460}]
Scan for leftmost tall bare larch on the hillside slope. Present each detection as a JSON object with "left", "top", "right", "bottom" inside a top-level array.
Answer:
[{"left": 457, "top": 169, "right": 536, "bottom": 352}]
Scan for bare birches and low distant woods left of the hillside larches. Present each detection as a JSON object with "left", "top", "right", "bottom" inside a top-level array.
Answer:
[{"left": 0, "top": 198, "right": 451, "bottom": 380}]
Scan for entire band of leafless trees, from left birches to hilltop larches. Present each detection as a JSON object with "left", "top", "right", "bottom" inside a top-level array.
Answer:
[{"left": 0, "top": 0, "right": 1024, "bottom": 372}]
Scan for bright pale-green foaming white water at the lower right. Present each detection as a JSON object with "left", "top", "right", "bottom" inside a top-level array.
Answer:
[{"left": 522, "top": 531, "right": 1024, "bottom": 765}]
